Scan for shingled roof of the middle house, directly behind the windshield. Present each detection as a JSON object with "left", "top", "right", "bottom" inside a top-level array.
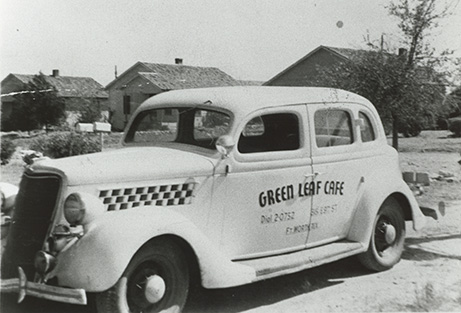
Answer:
[{"left": 106, "top": 62, "right": 239, "bottom": 90}]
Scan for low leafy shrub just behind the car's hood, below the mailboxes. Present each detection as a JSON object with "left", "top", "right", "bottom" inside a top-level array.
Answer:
[{"left": 30, "top": 131, "right": 101, "bottom": 159}]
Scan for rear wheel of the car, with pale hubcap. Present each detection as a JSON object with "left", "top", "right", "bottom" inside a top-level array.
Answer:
[{"left": 358, "top": 198, "right": 405, "bottom": 271}]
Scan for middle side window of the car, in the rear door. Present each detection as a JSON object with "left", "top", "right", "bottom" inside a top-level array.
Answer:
[{"left": 314, "top": 109, "right": 354, "bottom": 148}]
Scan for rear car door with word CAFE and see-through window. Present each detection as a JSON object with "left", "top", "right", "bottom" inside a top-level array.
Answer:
[{"left": 307, "top": 104, "right": 373, "bottom": 246}]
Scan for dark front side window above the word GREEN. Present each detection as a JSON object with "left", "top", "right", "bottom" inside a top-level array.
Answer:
[{"left": 237, "top": 113, "right": 300, "bottom": 153}]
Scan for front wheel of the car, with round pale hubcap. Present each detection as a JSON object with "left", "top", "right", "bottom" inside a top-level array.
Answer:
[{"left": 96, "top": 240, "right": 189, "bottom": 313}]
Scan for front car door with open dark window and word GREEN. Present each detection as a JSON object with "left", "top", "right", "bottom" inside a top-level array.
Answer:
[{"left": 212, "top": 105, "right": 312, "bottom": 259}]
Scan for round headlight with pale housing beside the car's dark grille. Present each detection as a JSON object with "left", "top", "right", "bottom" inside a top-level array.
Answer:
[{"left": 64, "top": 192, "right": 105, "bottom": 226}]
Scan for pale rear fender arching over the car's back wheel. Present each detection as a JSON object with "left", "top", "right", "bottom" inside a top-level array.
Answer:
[{"left": 347, "top": 172, "right": 426, "bottom": 247}]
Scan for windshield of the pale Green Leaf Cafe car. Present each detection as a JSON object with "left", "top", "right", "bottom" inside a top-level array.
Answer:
[{"left": 125, "top": 108, "right": 230, "bottom": 149}]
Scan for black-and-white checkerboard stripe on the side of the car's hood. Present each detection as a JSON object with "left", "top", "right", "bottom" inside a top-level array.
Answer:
[{"left": 99, "top": 183, "right": 196, "bottom": 211}]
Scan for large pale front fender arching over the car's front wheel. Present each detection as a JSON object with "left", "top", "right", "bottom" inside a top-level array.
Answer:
[{"left": 54, "top": 207, "right": 255, "bottom": 292}]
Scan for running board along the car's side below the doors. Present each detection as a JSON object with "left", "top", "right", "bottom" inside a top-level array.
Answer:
[{"left": 236, "top": 241, "right": 366, "bottom": 281}]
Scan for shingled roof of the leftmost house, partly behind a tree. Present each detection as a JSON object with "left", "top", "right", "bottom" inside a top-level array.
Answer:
[{"left": 2, "top": 74, "right": 108, "bottom": 98}]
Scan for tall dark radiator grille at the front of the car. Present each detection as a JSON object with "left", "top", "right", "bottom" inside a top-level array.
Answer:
[{"left": 2, "top": 174, "right": 61, "bottom": 279}]
